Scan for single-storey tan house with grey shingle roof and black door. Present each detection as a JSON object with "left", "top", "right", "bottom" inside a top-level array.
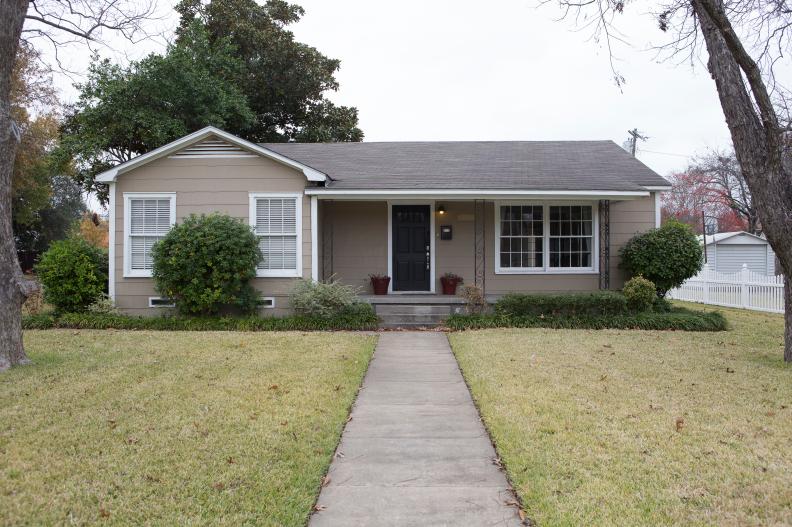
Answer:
[{"left": 97, "top": 127, "right": 670, "bottom": 314}]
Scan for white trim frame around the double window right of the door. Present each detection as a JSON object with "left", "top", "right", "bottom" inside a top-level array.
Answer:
[{"left": 494, "top": 201, "right": 599, "bottom": 275}]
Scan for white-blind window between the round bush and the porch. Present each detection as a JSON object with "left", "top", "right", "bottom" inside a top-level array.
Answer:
[{"left": 255, "top": 197, "right": 297, "bottom": 271}]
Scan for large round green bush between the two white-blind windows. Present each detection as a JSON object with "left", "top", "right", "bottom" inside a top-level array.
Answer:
[{"left": 151, "top": 213, "right": 261, "bottom": 315}]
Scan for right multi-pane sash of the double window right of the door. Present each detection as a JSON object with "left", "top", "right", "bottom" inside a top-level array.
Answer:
[{"left": 550, "top": 205, "right": 594, "bottom": 268}]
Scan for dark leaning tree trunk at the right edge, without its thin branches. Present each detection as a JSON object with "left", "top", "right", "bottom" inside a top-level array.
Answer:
[{"left": 691, "top": 0, "right": 792, "bottom": 362}]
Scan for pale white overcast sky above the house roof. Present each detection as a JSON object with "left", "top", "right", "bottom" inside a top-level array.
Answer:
[{"left": 49, "top": 0, "right": 756, "bottom": 179}]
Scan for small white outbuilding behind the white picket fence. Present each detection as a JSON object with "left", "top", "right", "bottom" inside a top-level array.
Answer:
[{"left": 698, "top": 231, "right": 775, "bottom": 276}]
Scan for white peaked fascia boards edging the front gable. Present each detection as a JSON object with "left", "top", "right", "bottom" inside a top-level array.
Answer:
[{"left": 96, "top": 126, "right": 327, "bottom": 183}]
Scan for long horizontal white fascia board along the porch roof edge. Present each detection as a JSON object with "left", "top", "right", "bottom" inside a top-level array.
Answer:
[{"left": 305, "top": 188, "right": 650, "bottom": 200}]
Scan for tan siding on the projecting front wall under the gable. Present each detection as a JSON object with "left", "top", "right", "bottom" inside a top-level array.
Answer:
[{"left": 114, "top": 153, "right": 311, "bottom": 315}]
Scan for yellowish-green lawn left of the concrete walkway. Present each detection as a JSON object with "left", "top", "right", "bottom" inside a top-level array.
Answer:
[{"left": 0, "top": 330, "right": 375, "bottom": 526}]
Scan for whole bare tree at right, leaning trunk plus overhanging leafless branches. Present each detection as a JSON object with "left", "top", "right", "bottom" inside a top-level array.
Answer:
[{"left": 545, "top": 0, "right": 792, "bottom": 362}]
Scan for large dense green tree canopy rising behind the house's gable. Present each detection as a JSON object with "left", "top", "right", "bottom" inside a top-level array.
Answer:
[{"left": 62, "top": 0, "right": 363, "bottom": 198}]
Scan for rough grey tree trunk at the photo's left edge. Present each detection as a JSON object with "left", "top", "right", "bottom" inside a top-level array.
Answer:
[{"left": 0, "top": 0, "right": 35, "bottom": 371}]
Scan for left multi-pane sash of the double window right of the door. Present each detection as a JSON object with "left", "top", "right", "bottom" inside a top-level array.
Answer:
[{"left": 500, "top": 205, "right": 544, "bottom": 269}]
